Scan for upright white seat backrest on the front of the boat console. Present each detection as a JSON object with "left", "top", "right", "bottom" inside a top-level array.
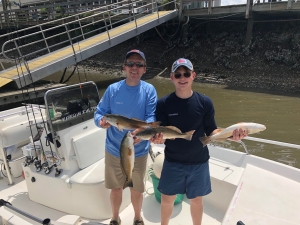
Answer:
[{"left": 72, "top": 127, "right": 106, "bottom": 169}]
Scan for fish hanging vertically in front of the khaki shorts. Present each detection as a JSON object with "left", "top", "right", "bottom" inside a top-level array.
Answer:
[{"left": 120, "top": 131, "right": 135, "bottom": 189}]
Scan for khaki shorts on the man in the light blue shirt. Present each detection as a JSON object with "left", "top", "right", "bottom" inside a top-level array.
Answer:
[{"left": 105, "top": 151, "right": 148, "bottom": 193}]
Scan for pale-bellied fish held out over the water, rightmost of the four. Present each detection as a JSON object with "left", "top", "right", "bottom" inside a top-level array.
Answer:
[{"left": 200, "top": 122, "right": 266, "bottom": 146}]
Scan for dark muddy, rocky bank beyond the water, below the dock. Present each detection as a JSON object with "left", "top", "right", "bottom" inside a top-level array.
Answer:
[{"left": 0, "top": 21, "right": 300, "bottom": 96}]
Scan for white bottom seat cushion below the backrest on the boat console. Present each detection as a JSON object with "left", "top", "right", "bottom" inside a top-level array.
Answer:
[{"left": 70, "top": 158, "right": 105, "bottom": 185}]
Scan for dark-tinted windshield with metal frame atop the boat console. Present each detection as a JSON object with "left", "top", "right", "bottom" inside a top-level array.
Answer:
[{"left": 44, "top": 82, "right": 99, "bottom": 132}]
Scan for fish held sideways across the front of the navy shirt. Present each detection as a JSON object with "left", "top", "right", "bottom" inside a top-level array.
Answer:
[{"left": 135, "top": 126, "right": 195, "bottom": 141}]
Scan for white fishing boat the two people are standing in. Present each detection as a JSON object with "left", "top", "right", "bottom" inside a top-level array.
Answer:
[{"left": 0, "top": 82, "right": 300, "bottom": 225}]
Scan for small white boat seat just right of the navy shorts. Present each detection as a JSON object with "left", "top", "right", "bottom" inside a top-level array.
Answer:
[{"left": 209, "top": 157, "right": 244, "bottom": 186}]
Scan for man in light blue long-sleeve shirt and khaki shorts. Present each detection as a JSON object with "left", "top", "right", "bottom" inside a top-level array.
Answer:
[{"left": 94, "top": 49, "right": 157, "bottom": 225}]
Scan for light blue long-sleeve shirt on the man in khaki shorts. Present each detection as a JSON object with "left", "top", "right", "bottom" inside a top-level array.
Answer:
[{"left": 94, "top": 80, "right": 157, "bottom": 158}]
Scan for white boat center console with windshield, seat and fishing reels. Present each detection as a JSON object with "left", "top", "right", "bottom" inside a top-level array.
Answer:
[{"left": 19, "top": 82, "right": 130, "bottom": 219}]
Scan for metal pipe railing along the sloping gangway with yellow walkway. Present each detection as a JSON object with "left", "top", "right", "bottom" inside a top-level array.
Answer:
[{"left": 0, "top": 0, "right": 176, "bottom": 60}]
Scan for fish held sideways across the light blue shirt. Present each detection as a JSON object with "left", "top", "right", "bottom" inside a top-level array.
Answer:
[{"left": 103, "top": 114, "right": 161, "bottom": 131}]
